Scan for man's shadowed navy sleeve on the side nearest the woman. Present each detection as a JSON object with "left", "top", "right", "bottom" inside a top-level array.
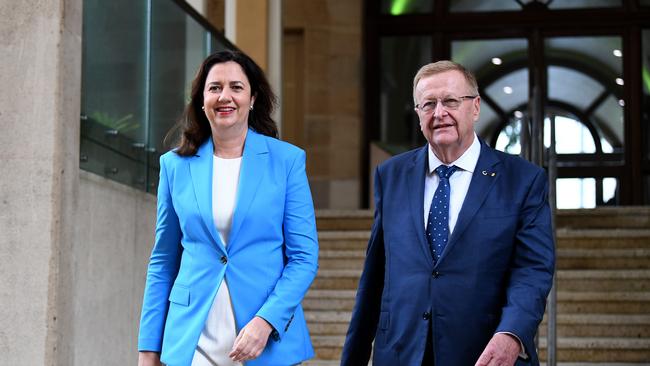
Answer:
[{"left": 341, "top": 168, "right": 386, "bottom": 366}]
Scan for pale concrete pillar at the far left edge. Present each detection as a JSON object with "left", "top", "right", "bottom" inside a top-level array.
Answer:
[{"left": 0, "top": 0, "right": 83, "bottom": 365}]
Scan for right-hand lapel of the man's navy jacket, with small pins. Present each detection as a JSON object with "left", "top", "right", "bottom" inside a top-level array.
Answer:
[{"left": 438, "top": 141, "right": 500, "bottom": 262}]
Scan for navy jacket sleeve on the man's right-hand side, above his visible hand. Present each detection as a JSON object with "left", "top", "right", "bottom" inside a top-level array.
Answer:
[{"left": 496, "top": 169, "right": 555, "bottom": 354}]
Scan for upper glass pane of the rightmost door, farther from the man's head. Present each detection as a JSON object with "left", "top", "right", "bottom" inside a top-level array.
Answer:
[{"left": 545, "top": 37, "right": 625, "bottom": 153}]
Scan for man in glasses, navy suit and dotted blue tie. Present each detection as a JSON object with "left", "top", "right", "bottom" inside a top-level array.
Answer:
[{"left": 341, "top": 61, "right": 555, "bottom": 366}]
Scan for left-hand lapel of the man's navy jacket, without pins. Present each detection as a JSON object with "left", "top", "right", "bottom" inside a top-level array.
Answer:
[{"left": 406, "top": 145, "right": 433, "bottom": 263}]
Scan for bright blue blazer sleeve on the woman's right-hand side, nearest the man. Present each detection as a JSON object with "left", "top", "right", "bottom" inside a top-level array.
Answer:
[{"left": 256, "top": 150, "right": 318, "bottom": 340}]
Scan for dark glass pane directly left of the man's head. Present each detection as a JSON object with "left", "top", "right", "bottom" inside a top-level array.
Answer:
[{"left": 380, "top": 37, "right": 431, "bottom": 151}]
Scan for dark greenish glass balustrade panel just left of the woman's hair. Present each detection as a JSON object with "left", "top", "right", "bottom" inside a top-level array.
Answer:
[{"left": 148, "top": 1, "right": 208, "bottom": 191}]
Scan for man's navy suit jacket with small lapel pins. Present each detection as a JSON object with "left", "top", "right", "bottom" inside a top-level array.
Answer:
[{"left": 341, "top": 142, "right": 555, "bottom": 366}]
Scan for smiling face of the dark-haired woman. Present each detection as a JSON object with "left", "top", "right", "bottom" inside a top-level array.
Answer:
[{"left": 203, "top": 61, "right": 255, "bottom": 131}]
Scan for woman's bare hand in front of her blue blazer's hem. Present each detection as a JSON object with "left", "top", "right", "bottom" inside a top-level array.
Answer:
[{"left": 228, "top": 316, "right": 273, "bottom": 362}]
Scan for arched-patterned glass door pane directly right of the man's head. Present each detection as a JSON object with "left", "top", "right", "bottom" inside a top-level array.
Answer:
[{"left": 451, "top": 39, "right": 528, "bottom": 145}]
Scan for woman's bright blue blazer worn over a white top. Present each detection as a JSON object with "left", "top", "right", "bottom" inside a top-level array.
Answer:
[{"left": 138, "top": 129, "right": 318, "bottom": 366}]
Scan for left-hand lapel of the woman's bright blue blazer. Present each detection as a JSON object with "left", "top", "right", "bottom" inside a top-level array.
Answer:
[{"left": 189, "top": 138, "right": 226, "bottom": 254}]
